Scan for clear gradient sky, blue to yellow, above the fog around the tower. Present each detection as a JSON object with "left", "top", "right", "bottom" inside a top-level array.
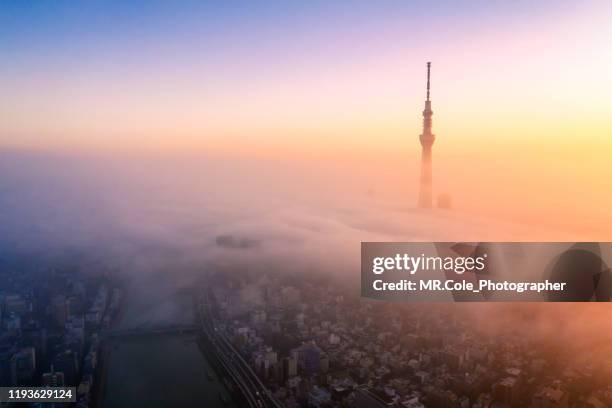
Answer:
[{"left": 0, "top": 0, "right": 612, "bottom": 233}]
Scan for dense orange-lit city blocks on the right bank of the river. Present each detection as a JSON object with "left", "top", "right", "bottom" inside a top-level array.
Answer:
[{"left": 203, "top": 270, "right": 612, "bottom": 408}]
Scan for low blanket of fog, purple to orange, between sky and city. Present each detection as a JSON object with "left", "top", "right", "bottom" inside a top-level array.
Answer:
[{"left": 0, "top": 152, "right": 612, "bottom": 366}]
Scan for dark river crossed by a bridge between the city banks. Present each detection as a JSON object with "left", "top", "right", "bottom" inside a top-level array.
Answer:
[{"left": 103, "top": 286, "right": 234, "bottom": 408}]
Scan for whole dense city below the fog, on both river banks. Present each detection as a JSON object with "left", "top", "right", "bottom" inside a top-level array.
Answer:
[{"left": 0, "top": 256, "right": 612, "bottom": 408}]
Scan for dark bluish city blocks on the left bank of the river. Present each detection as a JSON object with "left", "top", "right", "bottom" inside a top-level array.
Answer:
[{"left": 0, "top": 256, "right": 122, "bottom": 407}]
